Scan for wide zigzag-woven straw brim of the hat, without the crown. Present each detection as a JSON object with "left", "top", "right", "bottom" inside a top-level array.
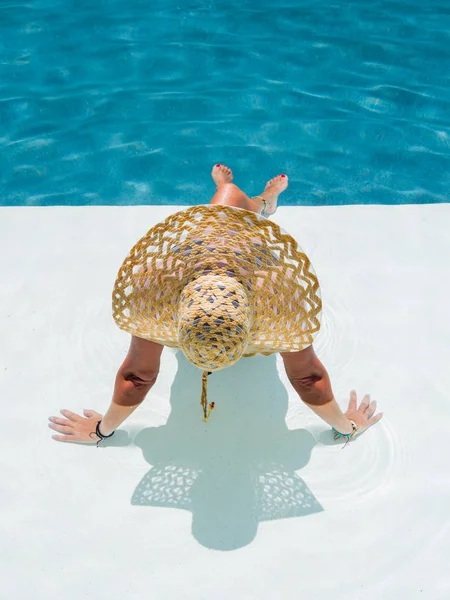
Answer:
[{"left": 112, "top": 204, "right": 322, "bottom": 356}]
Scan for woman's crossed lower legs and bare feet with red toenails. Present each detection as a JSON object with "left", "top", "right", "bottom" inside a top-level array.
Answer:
[{"left": 210, "top": 165, "right": 288, "bottom": 215}]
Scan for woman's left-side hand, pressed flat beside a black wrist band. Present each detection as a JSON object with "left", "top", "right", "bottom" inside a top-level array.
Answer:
[{"left": 48, "top": 409, "right": 103, "bottom": 444}]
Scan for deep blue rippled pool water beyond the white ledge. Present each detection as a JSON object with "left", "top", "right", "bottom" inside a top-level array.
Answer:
[{"left": 0, "top": 0, "right": 450, "bottom": 205}]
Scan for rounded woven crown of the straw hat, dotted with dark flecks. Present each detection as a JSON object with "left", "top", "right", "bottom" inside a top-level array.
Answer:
[{"left": 177, "top": 275, "right": 252, "bottom": 371}]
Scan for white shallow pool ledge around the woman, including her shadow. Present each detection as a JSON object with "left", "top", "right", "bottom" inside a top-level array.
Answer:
[{"left": 0, "top": 204, "right": 450, "bottom": 600}]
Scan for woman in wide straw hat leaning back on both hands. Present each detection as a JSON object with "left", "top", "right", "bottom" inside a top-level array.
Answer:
[{"left": 49, "top": 164, "right": 382, "bottom": 444}]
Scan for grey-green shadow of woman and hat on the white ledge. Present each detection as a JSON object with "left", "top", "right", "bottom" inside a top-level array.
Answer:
[{"left": 131, "top": 351, "right": 323, "bottom": 550}]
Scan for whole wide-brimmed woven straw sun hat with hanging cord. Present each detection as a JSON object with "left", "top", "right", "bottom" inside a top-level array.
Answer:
[{"left": 112, "top": 204, "right": 322, "bottom": 420}]
